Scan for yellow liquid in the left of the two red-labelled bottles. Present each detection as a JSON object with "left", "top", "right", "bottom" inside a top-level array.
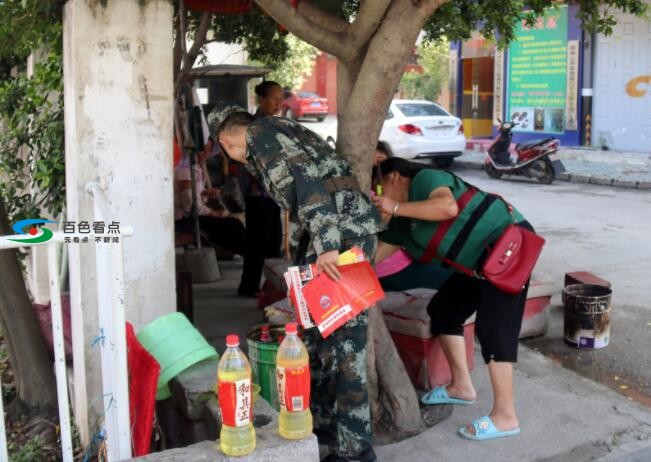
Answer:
[{"left": 217, "top": 348, "right": 255, "bottom": 456}]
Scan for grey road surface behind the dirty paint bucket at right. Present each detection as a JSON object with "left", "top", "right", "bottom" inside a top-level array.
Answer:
[{"left": 450, "top": 169, "right": 651, "bottom": 406}]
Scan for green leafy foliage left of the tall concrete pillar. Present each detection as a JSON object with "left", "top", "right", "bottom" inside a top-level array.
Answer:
[{"left": 0, "top": 0, "right": 65, "bottom": 220}]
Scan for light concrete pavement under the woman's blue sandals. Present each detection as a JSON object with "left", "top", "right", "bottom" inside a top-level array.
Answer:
[{"left": 376, "top": 347, "right": 651, "bottom": 462}]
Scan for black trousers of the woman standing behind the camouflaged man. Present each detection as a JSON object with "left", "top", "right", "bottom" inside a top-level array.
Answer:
[{"left": 239, "top": 197, "right": 283, "bottom": 293}]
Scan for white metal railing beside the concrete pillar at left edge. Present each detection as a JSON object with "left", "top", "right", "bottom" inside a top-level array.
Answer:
[{"left": 0, "top": 183, "right": 133, "bottom": 462}]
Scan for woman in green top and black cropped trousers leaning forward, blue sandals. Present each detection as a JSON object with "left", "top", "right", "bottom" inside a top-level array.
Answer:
[{"left": 373, "top": 158, "right": 532, "bottom": 440}]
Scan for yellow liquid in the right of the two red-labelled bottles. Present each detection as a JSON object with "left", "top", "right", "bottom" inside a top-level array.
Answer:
[{"left": 276, "top": 335, "right": 312, "bottom": 440}]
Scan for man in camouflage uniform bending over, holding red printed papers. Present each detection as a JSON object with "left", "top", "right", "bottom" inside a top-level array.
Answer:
[{"left": 215, "top": 106, "right": 381, "bottom": 462}]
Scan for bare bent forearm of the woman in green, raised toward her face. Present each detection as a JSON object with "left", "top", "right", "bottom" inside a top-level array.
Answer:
[{"left": 373, "top": 186, "right": 459, "bottom": 221}]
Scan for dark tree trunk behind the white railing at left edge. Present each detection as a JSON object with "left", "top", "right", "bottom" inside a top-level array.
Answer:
[{"left": 0, "top": 197, "right": 57, "bottom": 410}]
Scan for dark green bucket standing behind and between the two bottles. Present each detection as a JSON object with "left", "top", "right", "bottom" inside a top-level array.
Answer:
[{"left": 246, "top": 326, "right": 285, "bottom": 410}]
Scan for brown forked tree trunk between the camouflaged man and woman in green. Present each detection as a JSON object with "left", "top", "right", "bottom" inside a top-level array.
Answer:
[{"left": 255, "top": 0, "right": 454, "bottom": 435}]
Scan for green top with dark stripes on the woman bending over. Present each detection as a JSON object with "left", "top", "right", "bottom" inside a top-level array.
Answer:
[{"left": 380, "top": 169, "right": 524, "bottom": 268}]
